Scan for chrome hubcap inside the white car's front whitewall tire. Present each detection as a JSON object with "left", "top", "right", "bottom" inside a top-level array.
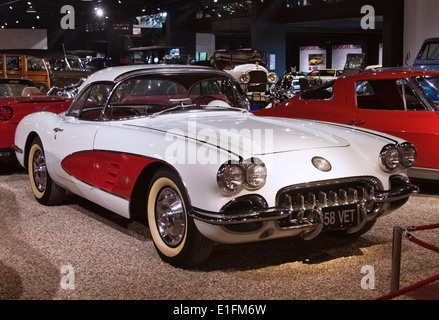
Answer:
[{"left": 155, "top": 187, "right": 186, "bottom": 247}]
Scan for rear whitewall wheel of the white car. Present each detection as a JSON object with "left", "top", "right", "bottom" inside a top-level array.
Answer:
[{"left": 27, "top": 137, "right": 65, "bottom": 206}]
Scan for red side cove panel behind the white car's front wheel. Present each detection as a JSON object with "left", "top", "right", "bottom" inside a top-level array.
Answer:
[{"left": 62, "top": 150, "right": 156, "bottom": 199}]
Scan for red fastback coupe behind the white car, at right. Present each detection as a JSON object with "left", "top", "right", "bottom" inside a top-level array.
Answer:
[{"left": 254, "top": 68, "right": 439, "bottom": 180}]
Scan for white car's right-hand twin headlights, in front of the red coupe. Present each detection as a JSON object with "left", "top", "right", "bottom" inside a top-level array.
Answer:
[{"left": 380, "top": 142, "right": 417, "bottom": 171}]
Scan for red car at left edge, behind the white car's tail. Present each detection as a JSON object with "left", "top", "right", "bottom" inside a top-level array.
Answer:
[{"left": 0, "top": 78, "right": 73, "bottom": 162}]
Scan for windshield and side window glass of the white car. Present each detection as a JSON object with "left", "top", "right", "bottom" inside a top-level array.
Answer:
[{"left": 68, "top": 74, "right": 248, "bottom": 121}]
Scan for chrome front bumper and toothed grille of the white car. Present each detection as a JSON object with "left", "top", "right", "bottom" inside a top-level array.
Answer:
[{"left": 190, "top": 176, "right": 419, "bottom": 229}]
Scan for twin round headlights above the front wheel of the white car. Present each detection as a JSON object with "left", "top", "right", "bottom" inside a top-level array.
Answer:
[{"left": 216, "top": 158, "right": 267, "bottom": 193}]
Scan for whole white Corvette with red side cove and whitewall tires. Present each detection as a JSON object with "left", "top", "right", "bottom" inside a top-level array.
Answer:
[{"left": 14, "top": 65, "right": 418, "bottom": 267}]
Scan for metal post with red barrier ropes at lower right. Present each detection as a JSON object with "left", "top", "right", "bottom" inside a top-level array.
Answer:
[{"left": 375, "top": 223, "right": 439, "bottom": 300}]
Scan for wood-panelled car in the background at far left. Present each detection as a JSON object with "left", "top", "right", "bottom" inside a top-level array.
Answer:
[{"left": 0, "top": 50, "right": 52, "bottom": 92}]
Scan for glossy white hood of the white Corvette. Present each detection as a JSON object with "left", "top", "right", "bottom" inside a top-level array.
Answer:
[{"left": 126, "top": 111, "right": 349, "bottom": 155}]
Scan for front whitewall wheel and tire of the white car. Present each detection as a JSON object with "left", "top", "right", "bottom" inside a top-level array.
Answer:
[{"left": 147, "top": 169, "right": 214, "bottom": 268}]
